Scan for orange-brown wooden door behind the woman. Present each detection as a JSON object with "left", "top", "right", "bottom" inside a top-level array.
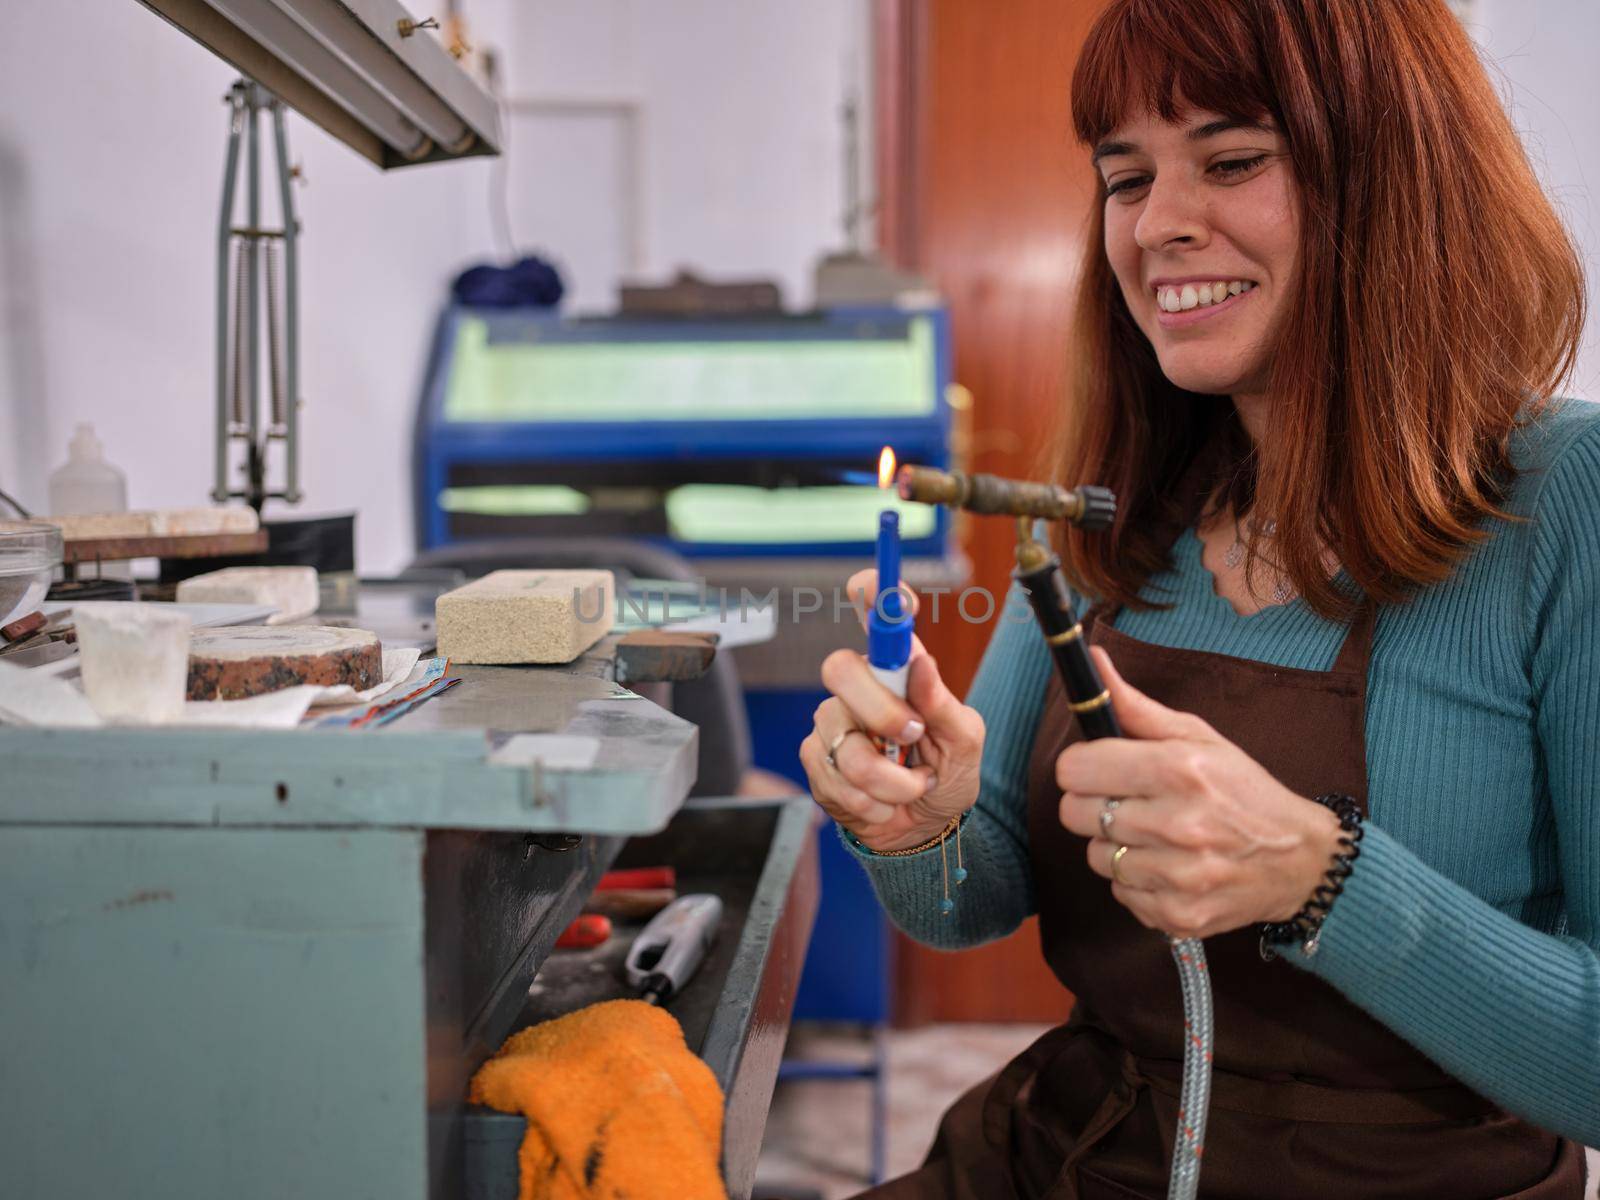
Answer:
[{"left": 877, "top": 0, "right": 1102, "bottom": 1024}]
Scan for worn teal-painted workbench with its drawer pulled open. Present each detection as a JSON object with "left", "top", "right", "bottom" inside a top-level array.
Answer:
[{"left": 0, "top": 589, "right": 818, "bottom": 1200}]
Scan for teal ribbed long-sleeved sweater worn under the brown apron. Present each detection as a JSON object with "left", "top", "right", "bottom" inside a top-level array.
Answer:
[{"left": 846, "top": 402, "right": 1600, "bottom": 1146}]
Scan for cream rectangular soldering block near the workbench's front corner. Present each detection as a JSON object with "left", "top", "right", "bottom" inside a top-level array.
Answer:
[{"left": 434, "top": 571, "right": 616, "bottom": 662}]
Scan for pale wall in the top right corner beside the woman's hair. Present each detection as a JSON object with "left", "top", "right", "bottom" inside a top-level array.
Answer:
[{"left": 1464, "top": 0, "right": 1600, "bottom": 400}]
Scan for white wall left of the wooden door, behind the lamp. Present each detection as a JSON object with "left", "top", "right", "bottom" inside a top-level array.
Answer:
[{"left": 0, "top": 0, "right": 866, "bottom": 573}]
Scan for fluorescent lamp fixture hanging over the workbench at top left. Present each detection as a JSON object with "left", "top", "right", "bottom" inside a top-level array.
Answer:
[{"left": 139, "top": 0, "right": 499, "bottom": 168}]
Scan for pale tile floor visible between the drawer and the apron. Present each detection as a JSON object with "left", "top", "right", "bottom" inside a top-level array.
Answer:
[{"left": 755, "top": 1026, "right": 1600, "bottom": 1200}]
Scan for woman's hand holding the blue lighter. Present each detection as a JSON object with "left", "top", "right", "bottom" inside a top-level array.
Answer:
[{"left": 800, "top": 570, "right": 984, "bottom": 853}]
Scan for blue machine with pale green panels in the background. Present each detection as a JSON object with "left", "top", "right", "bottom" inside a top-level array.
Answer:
[{"left": 414, "top": 309, "right": 950, "bottom": 1178}]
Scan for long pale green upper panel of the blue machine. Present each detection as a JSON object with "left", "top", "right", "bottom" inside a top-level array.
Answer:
[{"left": 445, "top": 315, "right": 936, "bottom": 422}]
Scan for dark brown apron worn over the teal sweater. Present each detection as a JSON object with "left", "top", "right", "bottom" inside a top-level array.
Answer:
[{"left": 867, "top": 588, "right": 1584, "bottom": 1200}]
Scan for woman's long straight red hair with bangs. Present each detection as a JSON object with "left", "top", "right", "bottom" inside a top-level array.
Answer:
[{"left": 1053, "top": 0, "right": 1584, "bottom": 618}]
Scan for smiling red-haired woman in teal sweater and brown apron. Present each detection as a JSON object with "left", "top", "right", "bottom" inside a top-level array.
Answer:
[{"left": 802, "top": 0, "right": 1600, "bottom": 1200}]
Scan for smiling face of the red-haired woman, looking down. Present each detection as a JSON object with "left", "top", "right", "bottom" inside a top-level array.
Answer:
[{"left": 1094, "top": 110, "right": 1299, "bottom": 395}]
